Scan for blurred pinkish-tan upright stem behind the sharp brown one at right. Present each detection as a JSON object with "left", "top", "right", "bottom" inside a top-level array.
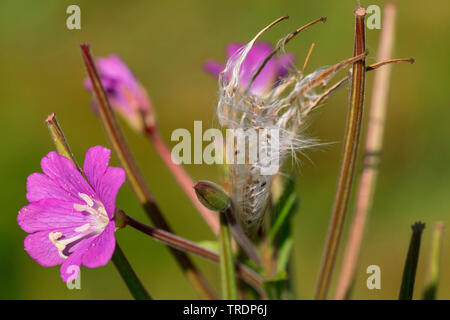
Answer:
[{"left": 335, "top": 3, "right": 396, "bottom": 300}]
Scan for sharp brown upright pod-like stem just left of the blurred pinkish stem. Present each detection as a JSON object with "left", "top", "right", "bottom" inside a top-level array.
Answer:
[{"left": 315, "top": 7, "right": 367, "bottom": 299}]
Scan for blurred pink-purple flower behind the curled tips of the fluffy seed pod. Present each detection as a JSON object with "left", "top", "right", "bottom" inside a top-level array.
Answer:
[{"left": 204, "top": 42, "right": 294, "bottom": 95}]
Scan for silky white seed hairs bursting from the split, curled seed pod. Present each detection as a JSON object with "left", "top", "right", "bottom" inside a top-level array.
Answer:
[{"left": 217, "top": 17, "right": 368, "bottom": 238}]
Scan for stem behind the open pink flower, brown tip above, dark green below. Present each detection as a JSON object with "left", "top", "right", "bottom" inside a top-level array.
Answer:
[{"left": 45, "top": 113, "right": 151, "bottom": 300}]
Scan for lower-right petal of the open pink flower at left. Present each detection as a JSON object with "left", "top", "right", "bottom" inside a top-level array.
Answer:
[{"left": 82, "top": 221, "right": 116, "bottom": 268}]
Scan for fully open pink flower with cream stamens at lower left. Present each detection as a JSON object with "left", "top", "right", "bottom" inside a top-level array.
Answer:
[{"left": 17, "top": 146, "right": 125, "bottom": 282}]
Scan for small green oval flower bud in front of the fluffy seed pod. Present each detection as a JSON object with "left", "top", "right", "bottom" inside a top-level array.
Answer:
[{"left": 194, "top": 181, "right": 230, "bottom": 212}]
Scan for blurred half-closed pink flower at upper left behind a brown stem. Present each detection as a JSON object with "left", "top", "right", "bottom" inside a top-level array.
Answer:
[{"left": 84, "top": 55, "right": 154, "bottom": 131}]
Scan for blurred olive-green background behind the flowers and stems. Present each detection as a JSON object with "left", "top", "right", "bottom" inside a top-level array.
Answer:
[{"left": 0, "top": 0, "right": 450, "bottom": 299}]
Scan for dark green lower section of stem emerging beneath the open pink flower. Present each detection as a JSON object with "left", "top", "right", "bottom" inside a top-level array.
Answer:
[{"left": 112, "top": 242, "right": 152, "bottom": 300}]
